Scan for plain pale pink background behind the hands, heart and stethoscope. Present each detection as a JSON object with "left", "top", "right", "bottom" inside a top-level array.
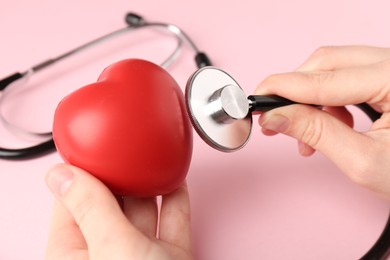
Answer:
[{"left": 0, "top": 0, "right": 390, "bottom": 260}]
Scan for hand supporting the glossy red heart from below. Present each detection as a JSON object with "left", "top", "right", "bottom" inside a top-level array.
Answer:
[{"left": 46, "top": 165, "right": 192, "bottom": 260}]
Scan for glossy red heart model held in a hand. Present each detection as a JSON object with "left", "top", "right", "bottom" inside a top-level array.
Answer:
[{"left": 53, "top": 59, "right": 192, "bottom": 197}]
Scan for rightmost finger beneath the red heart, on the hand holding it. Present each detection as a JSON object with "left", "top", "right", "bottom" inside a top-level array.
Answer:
[{"left": 159, "top": 184, "right": 191, "bottom": 252}]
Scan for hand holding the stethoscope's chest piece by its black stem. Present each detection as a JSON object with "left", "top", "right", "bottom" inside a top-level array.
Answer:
[{"left": 255, "top": 46, "right": 390, "bottom": 199}]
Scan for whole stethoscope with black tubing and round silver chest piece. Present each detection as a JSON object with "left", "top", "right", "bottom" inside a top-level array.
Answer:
[{"left": 0, "top": 13, "right": 390, "bottom": 260}]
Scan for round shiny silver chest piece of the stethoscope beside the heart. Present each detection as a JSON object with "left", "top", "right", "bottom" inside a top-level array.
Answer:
[{"left": 185, "top": 67, "right": 252, "bottom": 152}]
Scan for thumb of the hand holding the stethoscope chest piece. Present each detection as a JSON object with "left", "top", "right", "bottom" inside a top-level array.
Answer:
[{"left": 259, "top": 105, "right": 373, "bottom": 183}]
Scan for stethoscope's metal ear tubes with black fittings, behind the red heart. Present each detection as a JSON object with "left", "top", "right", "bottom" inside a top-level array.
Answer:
[{"left": 0, "top": 12, "right": 211, "bottom": 160}]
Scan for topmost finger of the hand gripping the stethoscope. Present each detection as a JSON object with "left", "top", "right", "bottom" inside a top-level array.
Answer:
[{"left": 297, "top": 46, "right": 390, "bottom": 71}]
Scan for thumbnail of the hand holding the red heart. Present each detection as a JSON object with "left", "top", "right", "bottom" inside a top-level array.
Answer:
[{"left": 46, "top": 167, "right": 74, "bottom": 197}]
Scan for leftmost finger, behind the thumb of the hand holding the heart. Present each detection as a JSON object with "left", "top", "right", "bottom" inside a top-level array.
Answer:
[{"left": 46, "top": 200, "right": 88, "bottom": 260}]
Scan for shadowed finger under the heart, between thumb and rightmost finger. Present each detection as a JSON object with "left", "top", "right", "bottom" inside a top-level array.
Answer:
[{"left": 123, "top": 197, "right": 158, "bottom": 238}]
